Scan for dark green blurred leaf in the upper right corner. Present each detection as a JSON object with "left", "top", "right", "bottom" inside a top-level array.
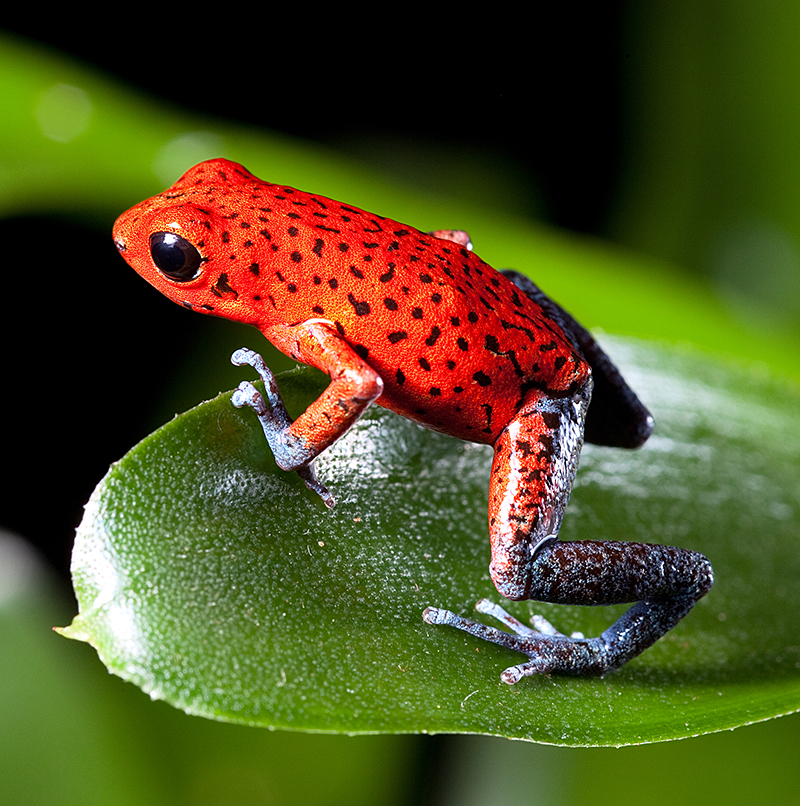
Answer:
[{"left": 609, "top": 0, "right": 800, "bottom": 344}]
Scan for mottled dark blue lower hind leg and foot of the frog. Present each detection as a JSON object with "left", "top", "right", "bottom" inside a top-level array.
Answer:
[{"left": 423, "top": 541, "right": 714, "bottom": 683}]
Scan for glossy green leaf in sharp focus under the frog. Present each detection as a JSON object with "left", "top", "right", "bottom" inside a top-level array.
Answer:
[{"left": 64, "top": 338, "right": 800, "bottom": 745}]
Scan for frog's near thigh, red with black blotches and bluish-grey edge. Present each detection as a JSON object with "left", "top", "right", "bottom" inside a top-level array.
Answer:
[{"left": 489, "top": 380, "right": 591, "bottom": 599}]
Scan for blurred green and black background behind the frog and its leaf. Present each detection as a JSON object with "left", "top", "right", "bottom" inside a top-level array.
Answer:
[{"left": 0, "top": 0, "right": 800, "bottom": 804}]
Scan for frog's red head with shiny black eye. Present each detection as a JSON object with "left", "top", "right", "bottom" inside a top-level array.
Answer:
[{"left": 114, "top": 159, "right": 270, "bottom": 322}]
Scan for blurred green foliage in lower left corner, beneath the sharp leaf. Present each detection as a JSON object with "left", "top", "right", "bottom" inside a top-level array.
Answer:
[{"left": 0, "top": 530, "right": 418, "bottom": 806}]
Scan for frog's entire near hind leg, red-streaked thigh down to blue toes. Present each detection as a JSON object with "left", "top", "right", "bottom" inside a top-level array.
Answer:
[{"left": 424, "top": 390, "right": 713, "bottom": 683}]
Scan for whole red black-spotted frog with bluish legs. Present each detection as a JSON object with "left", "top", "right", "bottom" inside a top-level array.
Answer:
[{"left": 114, "top": 159, "right": 713, "bottom": 683}]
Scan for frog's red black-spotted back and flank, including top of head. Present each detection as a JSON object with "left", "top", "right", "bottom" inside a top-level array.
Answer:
[{"left": 119, "top": 160, "right": 588, "bottom": 442}]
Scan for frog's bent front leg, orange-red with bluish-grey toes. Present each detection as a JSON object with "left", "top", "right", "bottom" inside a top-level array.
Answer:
[{"left": 231, "top": 320, "right": 383, "bottom": 506}]
